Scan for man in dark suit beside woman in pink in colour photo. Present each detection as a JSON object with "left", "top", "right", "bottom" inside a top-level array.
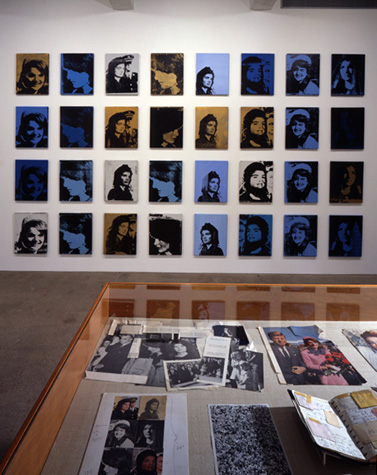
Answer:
[{"left": 268, "top": 332, "right": 306, "bottom": 384}]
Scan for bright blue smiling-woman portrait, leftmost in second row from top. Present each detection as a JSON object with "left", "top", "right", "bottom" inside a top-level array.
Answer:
[{"left": 16, "top": 107, "right": 48, "bottom": 148}]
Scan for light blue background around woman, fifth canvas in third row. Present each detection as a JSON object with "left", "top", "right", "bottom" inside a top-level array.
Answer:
[{"left": 195, "top": 160, "right": 228, "bottom": 203}]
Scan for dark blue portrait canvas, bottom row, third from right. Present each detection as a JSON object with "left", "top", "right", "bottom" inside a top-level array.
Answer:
[{"left": 238, "top": 214, "right": 272, "bottom": 257}]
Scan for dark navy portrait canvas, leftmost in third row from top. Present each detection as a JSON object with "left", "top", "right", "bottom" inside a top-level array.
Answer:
[{"left": 15, "top": 160, "right": 48, "bottom": 201}]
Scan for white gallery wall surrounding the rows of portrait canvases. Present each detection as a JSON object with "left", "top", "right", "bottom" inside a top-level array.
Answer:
[{"left": 0, "top": 0, "right": 377, "bottom": 274}]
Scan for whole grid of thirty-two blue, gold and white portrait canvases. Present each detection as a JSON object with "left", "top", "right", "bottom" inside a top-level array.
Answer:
[{"left": 14, "top": 53, "right": 365, "bottom": 257}]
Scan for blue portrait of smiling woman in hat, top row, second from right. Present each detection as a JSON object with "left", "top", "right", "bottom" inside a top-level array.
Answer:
[{"left": 286, "top": 54, "right": 320, "bottom": 96}]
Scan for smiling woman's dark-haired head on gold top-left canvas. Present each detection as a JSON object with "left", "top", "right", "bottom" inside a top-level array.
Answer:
[{"left": 16, "top": 58, "right": 49, "bottom": 95}]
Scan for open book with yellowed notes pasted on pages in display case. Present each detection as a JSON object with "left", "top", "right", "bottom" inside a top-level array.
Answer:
[{"left": 288, "top": 389, "right": 377, "bottom": 463}]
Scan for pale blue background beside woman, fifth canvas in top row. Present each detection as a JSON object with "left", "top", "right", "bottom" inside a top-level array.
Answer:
[{"left": 196, "top": 53, "right": 229, "bottom": 96}]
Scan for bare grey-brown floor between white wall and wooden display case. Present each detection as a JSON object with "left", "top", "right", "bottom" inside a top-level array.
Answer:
[{"left": 0, "top": 272, "right": 377, "bottom": 459}]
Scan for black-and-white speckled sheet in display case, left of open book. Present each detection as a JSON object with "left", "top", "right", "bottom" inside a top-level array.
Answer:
[{"left": 208, "top": 404, "right": 291, "bottom": 475}]
